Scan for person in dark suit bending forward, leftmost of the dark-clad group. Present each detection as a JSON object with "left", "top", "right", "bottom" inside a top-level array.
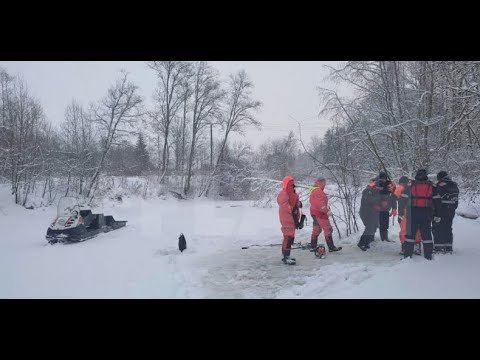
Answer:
[{"left": 357, "top": 179, "right": 382, "bottom": 251}]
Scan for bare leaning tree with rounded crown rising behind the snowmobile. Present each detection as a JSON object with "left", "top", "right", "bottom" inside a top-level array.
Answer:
[{"left": 84, "top": 71, "right": 142, "bottom": 197}]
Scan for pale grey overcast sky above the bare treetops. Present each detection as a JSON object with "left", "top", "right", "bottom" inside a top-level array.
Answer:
[{"left": 0, "top": 61, "right": 344, "bottom": 146}]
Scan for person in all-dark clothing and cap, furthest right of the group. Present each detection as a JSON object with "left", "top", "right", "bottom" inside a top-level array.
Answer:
[{"left": 432, "top": 170, "right": 459, "bottom": 253}]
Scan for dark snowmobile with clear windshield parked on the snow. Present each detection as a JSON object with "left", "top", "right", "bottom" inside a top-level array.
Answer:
[{"left": 46, "top": 196, "right": 127, "bottom": 244}]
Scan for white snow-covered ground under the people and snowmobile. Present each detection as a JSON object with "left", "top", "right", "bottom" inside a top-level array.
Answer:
[{"left": 0, "top": 186, "right": 480, "bottom": 298}]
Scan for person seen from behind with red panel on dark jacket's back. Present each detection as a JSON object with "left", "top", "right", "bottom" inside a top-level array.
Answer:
[{"left": 398, "top": 169, "right": 439, "bottom": 260}]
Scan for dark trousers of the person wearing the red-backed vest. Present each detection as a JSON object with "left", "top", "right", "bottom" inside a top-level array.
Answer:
[{"left": 404, "top": 207, "right": 433, "bottom": 259}]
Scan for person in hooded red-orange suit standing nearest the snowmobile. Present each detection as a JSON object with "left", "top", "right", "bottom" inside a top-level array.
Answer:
[{"left": 277, "top": 176, "right": 302, "bottom": 265}]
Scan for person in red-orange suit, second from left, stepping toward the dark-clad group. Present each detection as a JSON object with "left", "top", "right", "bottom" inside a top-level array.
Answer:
[{"left": 309, "top": 177, "right": 342, "bottom": 252}]
